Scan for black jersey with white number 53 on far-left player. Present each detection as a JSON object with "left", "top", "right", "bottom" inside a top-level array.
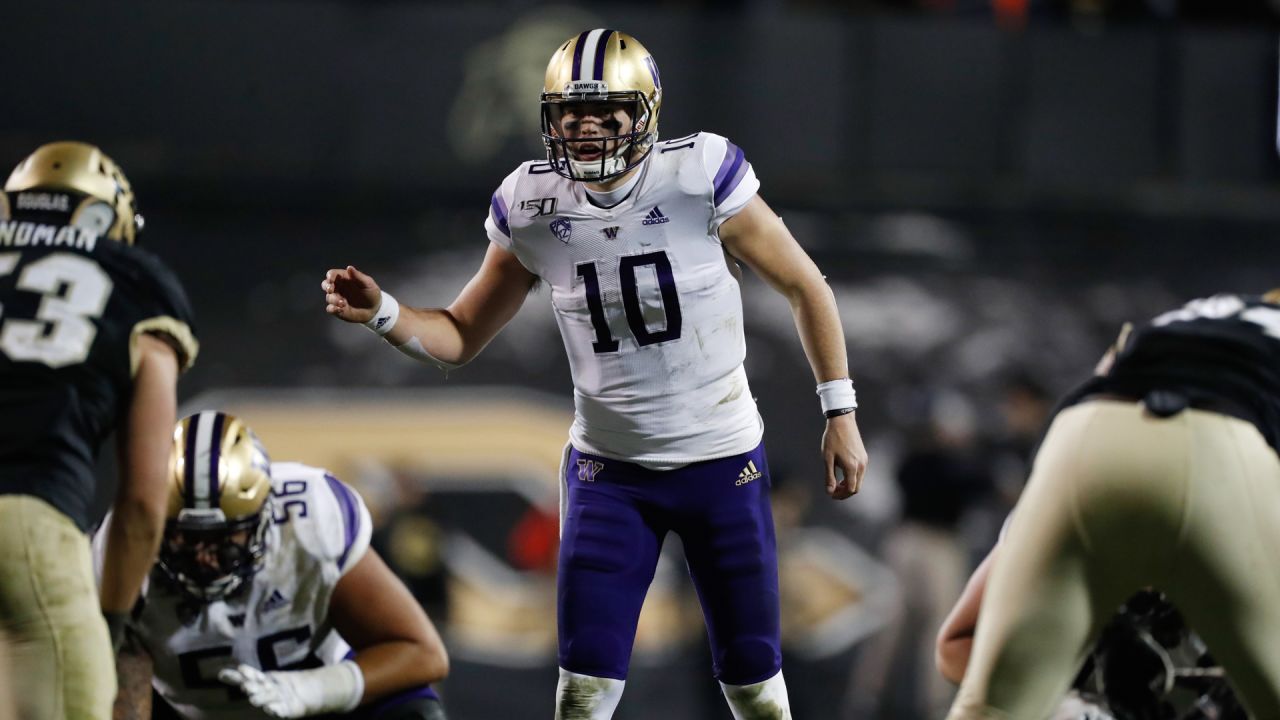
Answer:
[{"left": 0, "top": 212, "right": 197, "bottom": 530}]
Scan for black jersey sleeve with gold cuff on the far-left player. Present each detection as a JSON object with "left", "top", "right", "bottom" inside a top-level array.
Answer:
[{"left": 110, "top": 242, "right": 200, "bottom": 370}]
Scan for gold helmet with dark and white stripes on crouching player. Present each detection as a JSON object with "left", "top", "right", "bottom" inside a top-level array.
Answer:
[{"left": 159, "top": 411, "right": 271, "bottom": 602}]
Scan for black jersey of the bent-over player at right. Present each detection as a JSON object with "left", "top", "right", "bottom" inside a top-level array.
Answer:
[{"left": 1064, "top": 295, "right": 1280, "bottom": 452}]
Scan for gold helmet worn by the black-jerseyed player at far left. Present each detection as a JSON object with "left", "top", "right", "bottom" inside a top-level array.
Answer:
[{"left": 4, "top": 142, "right": 142, "bottom": 245}]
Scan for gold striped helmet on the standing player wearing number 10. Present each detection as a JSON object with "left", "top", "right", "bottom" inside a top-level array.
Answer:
[{"left": 541, "top": 28, "right": 662, "bottom": 182}]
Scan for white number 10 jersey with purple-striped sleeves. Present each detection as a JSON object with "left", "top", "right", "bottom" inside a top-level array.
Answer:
[{"left": 485, "top": 132, "right": 763, "bottom": 468}]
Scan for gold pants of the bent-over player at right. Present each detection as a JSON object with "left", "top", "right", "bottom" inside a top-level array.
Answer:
[{"left": 947, "top": 401, "right": 1280, "bottom": 720}]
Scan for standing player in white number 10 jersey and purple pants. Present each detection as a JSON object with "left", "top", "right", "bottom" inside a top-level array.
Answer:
[{"left": 321, "top": 29, "right": 867, "bottom": 719}]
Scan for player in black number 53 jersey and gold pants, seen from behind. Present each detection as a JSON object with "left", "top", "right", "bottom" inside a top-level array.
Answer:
[{"left": 0, "top": 142, "right": 197, "bottom": 717}]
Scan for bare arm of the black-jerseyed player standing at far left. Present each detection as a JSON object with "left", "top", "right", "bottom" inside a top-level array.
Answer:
[{"left": 100, "top": 334, "right": 178, "bottom": 612}]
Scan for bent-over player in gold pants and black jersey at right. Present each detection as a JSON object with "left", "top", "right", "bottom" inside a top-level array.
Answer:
[{"left": 940, "top": 291, "right": 1280, "bottom": 720}]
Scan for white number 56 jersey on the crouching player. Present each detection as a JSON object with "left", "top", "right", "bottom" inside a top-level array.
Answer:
[{"left": 95, "top": 462, "right": 372, "bottom": 719}]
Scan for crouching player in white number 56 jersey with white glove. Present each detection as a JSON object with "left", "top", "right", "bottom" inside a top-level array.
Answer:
[{"left": 108, "top": 411, "right": 448, "bottom": 720}]
